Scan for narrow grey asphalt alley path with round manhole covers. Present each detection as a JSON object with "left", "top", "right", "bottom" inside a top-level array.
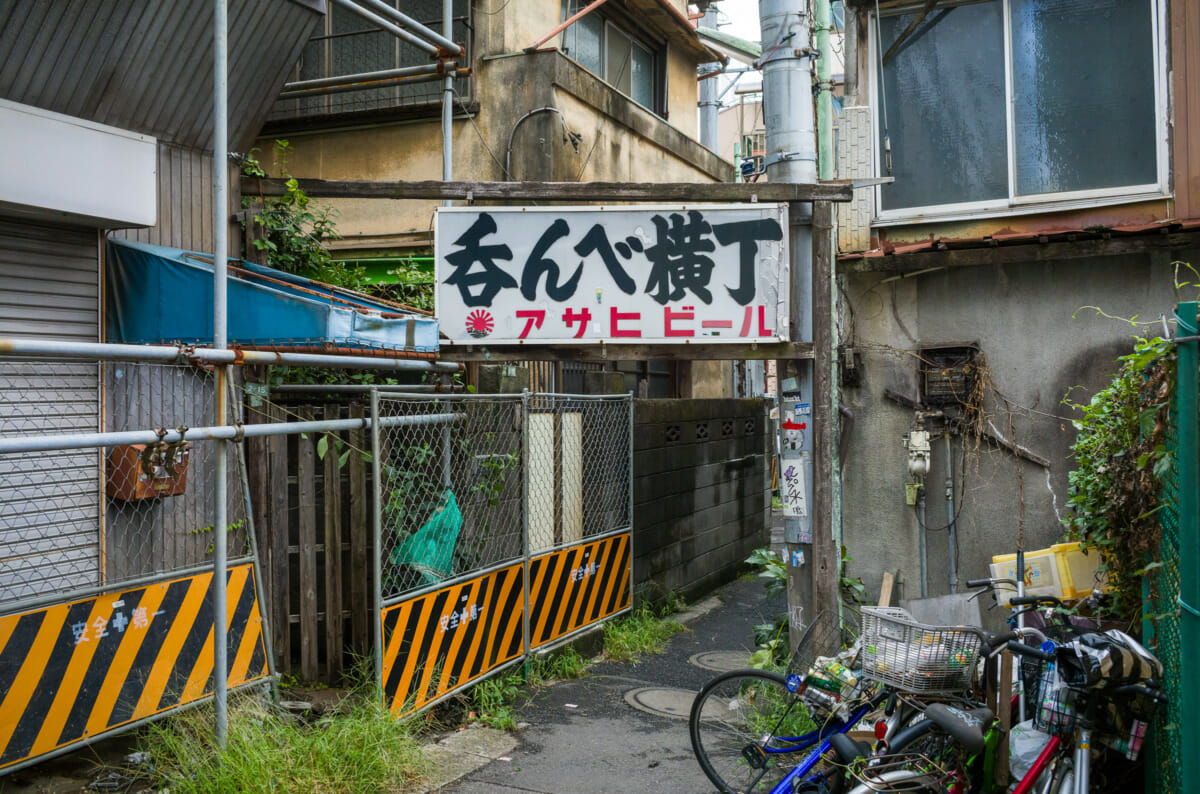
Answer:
[{"left": 442, "top": 579, "right": 785, "bottom": 794}]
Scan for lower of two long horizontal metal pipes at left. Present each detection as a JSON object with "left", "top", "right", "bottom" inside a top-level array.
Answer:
[{"left": 0, "top": 414, "right": 463, "bottom": 455}]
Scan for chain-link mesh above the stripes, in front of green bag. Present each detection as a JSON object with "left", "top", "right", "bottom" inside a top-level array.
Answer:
[{"left": 379, "top": 395, "right": 632, "bottom": 601}]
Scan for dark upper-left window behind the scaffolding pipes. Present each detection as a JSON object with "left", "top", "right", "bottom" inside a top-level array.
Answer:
[{"left": 268, "top": 0, "right": 470, "bottom": 122}]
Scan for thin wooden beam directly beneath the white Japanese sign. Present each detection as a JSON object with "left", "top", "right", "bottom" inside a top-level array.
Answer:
[{"left": 438, "top": 342, "right": 812, "bottom": 363}]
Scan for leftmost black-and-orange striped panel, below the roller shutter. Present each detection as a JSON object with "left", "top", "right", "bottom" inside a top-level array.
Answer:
[{"left": 0, "top": 563, "right": 269, "bottom": 772}]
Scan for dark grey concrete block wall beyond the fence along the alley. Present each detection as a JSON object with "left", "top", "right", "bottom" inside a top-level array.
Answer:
[{"left": 634, "top": 399, "right": 770, "bottom": 600}]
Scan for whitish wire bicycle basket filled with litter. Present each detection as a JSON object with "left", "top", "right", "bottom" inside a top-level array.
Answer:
[{"left": 859, "top": 607, "right": 984, "bottom": 693}]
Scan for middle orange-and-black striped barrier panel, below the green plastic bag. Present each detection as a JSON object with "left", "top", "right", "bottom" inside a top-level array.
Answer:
[{"left": 380, "top": 563, "right": 524, "bottom": 715}]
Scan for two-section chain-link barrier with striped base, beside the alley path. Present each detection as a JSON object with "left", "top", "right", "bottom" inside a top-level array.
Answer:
[{"left": 372, "top": 393, "right": 632, "bottom": 715}]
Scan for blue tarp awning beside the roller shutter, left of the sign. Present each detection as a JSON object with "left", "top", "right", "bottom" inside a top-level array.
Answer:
[{"left": 106, "top": 240, "right": 438, "bottom": 354}]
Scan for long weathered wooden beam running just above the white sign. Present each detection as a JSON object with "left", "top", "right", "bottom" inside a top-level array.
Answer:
[{"left": 240, "top": 176, "right": 854, "bottom": 203}]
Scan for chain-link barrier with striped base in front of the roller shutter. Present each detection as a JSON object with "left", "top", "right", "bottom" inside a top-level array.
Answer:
[{"left": 0, "top": 360, "right": 270, "bottom": 775}]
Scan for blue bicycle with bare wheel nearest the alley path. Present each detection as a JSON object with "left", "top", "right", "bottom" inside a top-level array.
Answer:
[{"left": 688, "top": 618, "right": 900, "bottom": 794}]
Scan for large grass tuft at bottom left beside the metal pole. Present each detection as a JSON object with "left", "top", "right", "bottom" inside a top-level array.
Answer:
[{"left": 139, "top": 699, "right": 426, "bottom": 794}]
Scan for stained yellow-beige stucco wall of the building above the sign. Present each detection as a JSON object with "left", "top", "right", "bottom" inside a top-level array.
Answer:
[{"left": 258, "top": 52, "right": 733, "bottom": 248}]
